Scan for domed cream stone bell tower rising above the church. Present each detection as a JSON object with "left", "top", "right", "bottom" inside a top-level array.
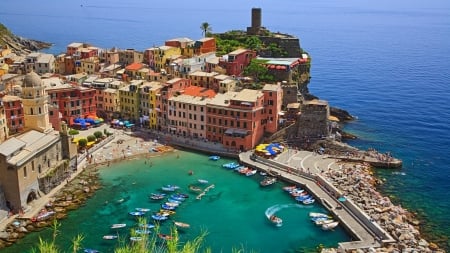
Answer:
[{"left": 21, "top": 72, "right": 53, "bottom": 133}]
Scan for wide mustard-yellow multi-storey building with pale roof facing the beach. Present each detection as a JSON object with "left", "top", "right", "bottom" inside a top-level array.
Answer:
[{"left": 119, "top": 80, "right": 143, "bottom": 122}]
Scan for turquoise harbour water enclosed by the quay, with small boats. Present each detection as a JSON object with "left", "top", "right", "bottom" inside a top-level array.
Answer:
[{"left": 1, "top": 152, "right": 350, "bottom": 253}]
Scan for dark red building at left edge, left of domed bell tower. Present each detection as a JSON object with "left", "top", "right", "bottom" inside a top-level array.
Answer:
[{"left": 2, "top": 95, "right": 25, "bottom": 136}]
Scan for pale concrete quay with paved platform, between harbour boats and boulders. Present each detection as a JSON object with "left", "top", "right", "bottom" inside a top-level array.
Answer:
[{"left": 239, "top": 150, "right": 395, "bottom": 251}]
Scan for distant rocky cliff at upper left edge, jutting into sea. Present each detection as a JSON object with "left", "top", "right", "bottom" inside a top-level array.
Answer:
[{"left": 0, "top": 23, "right": 52, "bottom": 54}]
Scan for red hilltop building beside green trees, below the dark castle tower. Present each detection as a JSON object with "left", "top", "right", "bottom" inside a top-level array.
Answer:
[{"left": 219, "top": 49, "right": 256, "bottom": 76}]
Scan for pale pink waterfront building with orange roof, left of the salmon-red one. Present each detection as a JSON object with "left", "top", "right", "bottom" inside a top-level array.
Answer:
[{"left": 168, "top": 86, "right": 216, "bottom": 138}]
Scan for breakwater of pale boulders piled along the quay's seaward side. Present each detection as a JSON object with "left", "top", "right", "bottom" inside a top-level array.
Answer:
[{"left": 322, "top": 163, "right": 445, "bottom": 253}]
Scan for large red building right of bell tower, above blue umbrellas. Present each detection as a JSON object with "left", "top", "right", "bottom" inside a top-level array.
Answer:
[{"left": 46, "top": 83, "right": 97, "bottom": 125}]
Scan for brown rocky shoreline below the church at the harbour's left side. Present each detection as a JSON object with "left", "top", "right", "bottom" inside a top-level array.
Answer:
[{"left": 0, "top": 168, "right": 101, "bottom": 248}]
